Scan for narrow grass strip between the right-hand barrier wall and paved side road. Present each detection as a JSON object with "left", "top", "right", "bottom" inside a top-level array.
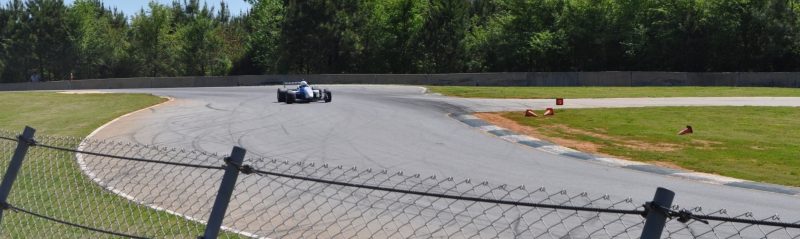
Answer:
[{"left": 428, "top": 86, "right": 800, "bottom": 99}]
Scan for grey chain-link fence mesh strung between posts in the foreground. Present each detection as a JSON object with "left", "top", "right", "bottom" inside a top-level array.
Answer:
[{"left": 0, "top": 131, "right": 800, "bottom": 238}]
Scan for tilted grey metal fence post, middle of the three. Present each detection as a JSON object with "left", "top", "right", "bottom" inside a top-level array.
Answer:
[{"left": 202, "top": 147, "right": 247, "bottom": 239}]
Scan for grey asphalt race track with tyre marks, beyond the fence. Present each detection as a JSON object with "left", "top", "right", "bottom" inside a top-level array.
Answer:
[{"left": 87, "top": 85, "right": 800, "bottom": 222}]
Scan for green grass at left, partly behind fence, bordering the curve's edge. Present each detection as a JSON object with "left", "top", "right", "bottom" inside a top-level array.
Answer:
[{"left": 0, "top": 93, "right": 241, "bottom": 238}]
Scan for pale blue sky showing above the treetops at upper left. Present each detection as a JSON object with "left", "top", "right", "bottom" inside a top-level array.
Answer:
[{"left": 0, "top": 0, "right": 250, "bottom": 16}]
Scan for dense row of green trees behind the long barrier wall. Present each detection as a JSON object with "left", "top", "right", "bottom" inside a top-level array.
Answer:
[{"left": 0, "top": 0, "right": 800, "bottom": 82}]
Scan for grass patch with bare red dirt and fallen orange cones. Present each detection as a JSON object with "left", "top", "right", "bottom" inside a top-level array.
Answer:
[{"left": 502, "top": 107, "right": 800, "bottom": 186}]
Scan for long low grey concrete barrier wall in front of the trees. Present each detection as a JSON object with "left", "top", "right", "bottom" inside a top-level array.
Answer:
[{"left": 0, "top": 71, "right": 800, "bottom": 91}]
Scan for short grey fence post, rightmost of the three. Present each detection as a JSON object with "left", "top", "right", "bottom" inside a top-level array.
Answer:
[{"left": 641, "top": 187, "right": 675, "bottom": 239}]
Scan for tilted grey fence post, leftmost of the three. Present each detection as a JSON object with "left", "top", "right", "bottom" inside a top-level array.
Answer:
[{"left": 0, "top": 126, "right": 36, "bottom": 222}]
